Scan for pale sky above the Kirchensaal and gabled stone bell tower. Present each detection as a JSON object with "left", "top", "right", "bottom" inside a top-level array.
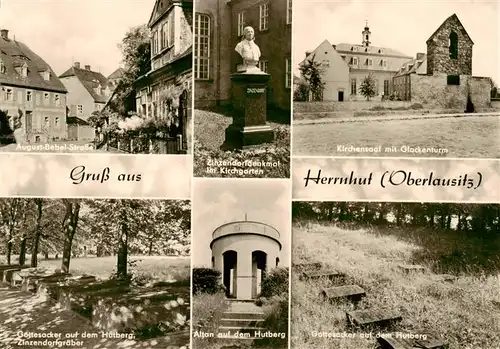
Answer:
[{"left": 293, "top": 0, "right": 500, "bottom": 84}]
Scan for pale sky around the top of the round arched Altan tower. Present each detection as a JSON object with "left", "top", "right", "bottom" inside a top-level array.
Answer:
[{"left": 191, "top": 178, "right": 292, "bottom": 267}]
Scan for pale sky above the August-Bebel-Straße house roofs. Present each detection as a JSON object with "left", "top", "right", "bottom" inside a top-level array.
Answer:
[{"left": 0, "top": 0, "right": 155, "bottom": 76}]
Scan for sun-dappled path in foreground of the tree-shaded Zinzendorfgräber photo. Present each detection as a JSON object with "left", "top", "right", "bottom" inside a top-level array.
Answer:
[{"left": 0, "top": 285, "right": 189, "bottom": 349}]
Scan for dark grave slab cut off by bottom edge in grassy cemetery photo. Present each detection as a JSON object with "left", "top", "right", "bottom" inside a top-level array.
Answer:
[{"left": 377, "top": 332, "right": 448, "bottom": 349}]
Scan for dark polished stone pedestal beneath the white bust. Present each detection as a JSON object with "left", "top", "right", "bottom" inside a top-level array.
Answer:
[{"left": 225, "top": 69, "right": 274, "bottom": 149}]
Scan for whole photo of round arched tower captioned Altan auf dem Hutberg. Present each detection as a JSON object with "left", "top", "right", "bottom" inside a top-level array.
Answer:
[{"left": 191, "top": 179, "right": 291, "bottom": 349}]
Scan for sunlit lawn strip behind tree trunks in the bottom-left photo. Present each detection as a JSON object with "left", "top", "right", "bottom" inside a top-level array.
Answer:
[{"left": 38, "top": 256, "right": 191, "bottom": 282}]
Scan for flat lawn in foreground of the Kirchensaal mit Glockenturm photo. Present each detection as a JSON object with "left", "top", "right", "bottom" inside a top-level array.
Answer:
[{"left": 293, "top": 116, "right": 500, "bottom": 158}]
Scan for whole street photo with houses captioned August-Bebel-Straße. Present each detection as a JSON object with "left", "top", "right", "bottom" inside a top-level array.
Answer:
[{"left": 0, "top": 0, "right": 193, "bottom": 154}]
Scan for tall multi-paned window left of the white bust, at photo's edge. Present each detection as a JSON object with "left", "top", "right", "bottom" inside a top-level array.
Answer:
[{"left": 194, "top": 13, "right": 211, "bottom": 80}]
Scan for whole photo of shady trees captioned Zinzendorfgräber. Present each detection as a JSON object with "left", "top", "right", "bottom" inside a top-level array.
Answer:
[{"left": 0, "top": 198, "right": 191, "bottom": 349}]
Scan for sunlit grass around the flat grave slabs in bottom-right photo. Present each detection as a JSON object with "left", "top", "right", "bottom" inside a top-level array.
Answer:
[{"left": 291, "top": 223, "right": 500, "bottom": 349}]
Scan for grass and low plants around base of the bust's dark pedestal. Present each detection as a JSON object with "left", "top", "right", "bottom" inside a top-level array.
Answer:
[{"left": 193, "top": 109, "right": 290, "bottom": 178}]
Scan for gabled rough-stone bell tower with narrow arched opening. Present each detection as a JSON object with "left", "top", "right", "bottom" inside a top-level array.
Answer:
[{"left": 427, "top": 17, "right": 473, "bottom": 75}]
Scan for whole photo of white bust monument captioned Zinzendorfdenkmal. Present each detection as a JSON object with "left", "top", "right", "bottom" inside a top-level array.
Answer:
[{"left": 193, "top": 0, "right": 292, "bottom": 178}]
